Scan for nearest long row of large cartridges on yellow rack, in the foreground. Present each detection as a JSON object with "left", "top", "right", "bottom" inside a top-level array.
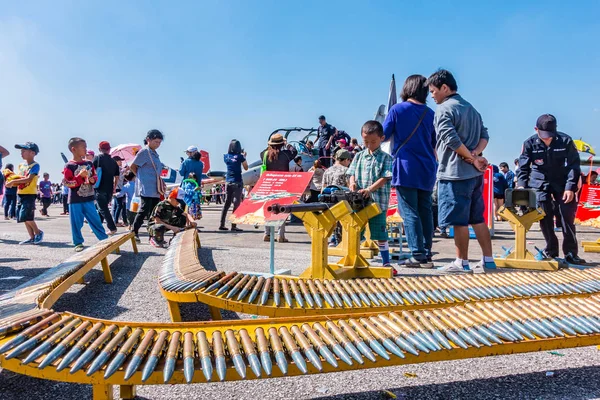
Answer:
[{"left": 0, "top": 295, "right": 600, "bottom": 385}]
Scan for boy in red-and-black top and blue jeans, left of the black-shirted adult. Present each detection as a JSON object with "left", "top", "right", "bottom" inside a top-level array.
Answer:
[{"left": 63, "top": 137, "right": 108, "bottom": 252}]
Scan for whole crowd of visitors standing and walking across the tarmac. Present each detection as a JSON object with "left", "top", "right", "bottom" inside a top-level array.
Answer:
[{"left": 0, "top": 70, "right": 597, "bottom": 273}]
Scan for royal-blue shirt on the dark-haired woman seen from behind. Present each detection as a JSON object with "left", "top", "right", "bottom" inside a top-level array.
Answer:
[{"left": 383, "top": 101, "right": 437, "bottom": 191}]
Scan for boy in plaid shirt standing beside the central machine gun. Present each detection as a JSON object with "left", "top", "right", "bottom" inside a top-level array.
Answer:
[{"left": 346, "top": 121, "right": 392, "bottom": 267}]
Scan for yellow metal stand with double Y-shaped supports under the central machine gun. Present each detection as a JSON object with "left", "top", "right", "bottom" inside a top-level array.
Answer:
[{"left": 293, "top": 201, "right": 392, "bottom": 279}]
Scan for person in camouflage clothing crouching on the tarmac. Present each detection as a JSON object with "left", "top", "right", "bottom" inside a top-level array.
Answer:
[{"left": 148, "top": 188, "right": 197, "bottom": 248}]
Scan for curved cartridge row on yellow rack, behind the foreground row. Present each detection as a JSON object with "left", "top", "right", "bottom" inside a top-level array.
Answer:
[{"left": 159, "top": 230, "right": 600, "bottom": 322}]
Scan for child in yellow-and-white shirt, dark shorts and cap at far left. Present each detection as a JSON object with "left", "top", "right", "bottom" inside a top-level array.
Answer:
[{"left": 7, "top": 142, "right": 44, "bottom": 244}]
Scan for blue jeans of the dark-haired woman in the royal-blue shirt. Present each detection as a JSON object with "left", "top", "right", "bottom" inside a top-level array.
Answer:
[{"left": 396, "top": 186, "right": 433, "bottom": 261}]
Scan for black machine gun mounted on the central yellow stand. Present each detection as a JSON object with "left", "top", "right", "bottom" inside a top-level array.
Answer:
[{"left": 267, "top": 185, "right": 373, "bottom": 214}]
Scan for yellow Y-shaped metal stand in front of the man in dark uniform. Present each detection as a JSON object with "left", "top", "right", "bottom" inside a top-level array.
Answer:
[{"left": 494, "top": 207, "right": 558, "bottom": 271}]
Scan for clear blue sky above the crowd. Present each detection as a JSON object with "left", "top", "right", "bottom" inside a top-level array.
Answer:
[{"left": 0, "top": 0, "right": 600, "bottom": 179}]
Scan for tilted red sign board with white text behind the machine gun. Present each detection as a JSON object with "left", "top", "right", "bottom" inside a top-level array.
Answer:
[{"left": 230, "top": 171, "right": 313, "bottom": 225}]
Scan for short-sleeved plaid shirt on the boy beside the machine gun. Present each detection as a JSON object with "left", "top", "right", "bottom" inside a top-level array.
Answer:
[{"left": 346, "top": 147, "right": 392, "bottom": 213}]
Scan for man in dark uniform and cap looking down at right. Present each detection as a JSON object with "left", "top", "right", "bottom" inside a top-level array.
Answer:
[{"left": 517, "top": 114, "right": 585, "bottom": 264}]
